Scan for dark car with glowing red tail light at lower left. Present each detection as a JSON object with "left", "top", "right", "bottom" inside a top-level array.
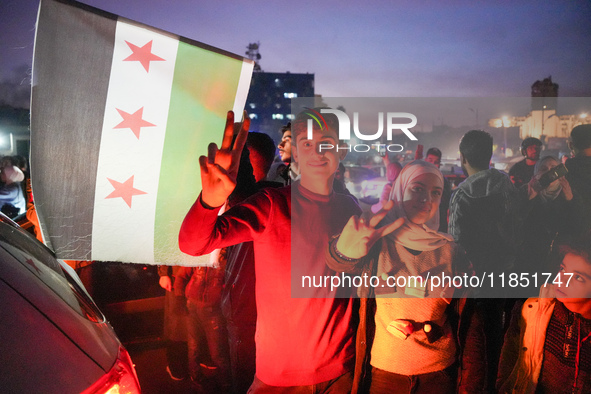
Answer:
[{"left": 0, "top": 214, "right": 140, "bottom": 394}]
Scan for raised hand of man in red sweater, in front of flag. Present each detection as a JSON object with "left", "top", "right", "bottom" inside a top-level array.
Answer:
[{"left": 199, "top": 111, "right": 250, "bottom": 207}]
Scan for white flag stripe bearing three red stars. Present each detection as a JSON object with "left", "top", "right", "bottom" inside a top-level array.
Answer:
[{"left": 92, "top": 18, "right": 178, "bottom": 263}]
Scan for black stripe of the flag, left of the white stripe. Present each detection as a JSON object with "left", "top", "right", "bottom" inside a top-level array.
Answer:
[{"left": 31, "top": 0, "right": 117, "bottom": 259}]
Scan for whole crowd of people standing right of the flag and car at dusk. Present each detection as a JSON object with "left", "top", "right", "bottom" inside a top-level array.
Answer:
[{"left": 161, "top": 109, "right": 591, "bottom": 393}]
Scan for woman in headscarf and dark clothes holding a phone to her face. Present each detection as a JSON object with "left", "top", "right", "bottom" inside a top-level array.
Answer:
[{"left": 517, "top": 156, "right": 576, "bottom": 273}]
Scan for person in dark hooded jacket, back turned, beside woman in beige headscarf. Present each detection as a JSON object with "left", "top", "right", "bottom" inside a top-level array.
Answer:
[{"left": 449, "top": 130, "right": 521, "bottom": 392}]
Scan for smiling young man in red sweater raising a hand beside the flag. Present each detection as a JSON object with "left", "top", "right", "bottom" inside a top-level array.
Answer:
[{"left": 179, "top": 109, "right": 361, "bottom": 393}]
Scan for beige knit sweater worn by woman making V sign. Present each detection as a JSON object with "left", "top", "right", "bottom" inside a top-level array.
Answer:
[{"left": 371, "top": 242, "right": 456, "bottom": 375}]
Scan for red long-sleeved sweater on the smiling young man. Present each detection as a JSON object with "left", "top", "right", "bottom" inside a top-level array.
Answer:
[{"left": 179, "top": 182, "right": 360, "bottom": 386}]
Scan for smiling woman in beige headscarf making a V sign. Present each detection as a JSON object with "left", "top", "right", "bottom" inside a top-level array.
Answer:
[{"left": 327, "top": 160, "right": 486, "bottom": 393}]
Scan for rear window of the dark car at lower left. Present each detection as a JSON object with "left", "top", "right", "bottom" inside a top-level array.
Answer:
[{"left": 0, "top": 222, "right": 104, "bottom": 322}]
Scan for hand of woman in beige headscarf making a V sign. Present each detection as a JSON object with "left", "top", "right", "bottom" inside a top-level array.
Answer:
[{"left": 336, "top": 200, "right": 404, "bottom": 259}]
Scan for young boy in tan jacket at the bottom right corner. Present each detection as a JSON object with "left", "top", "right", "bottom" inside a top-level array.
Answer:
[{"left": 497, "top": 235, "right": 591, "bottom": 393}]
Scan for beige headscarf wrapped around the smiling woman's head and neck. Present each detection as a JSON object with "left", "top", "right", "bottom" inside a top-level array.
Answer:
[{"left": 386, "top": 160, "right": 453, "bottom": 251}]
